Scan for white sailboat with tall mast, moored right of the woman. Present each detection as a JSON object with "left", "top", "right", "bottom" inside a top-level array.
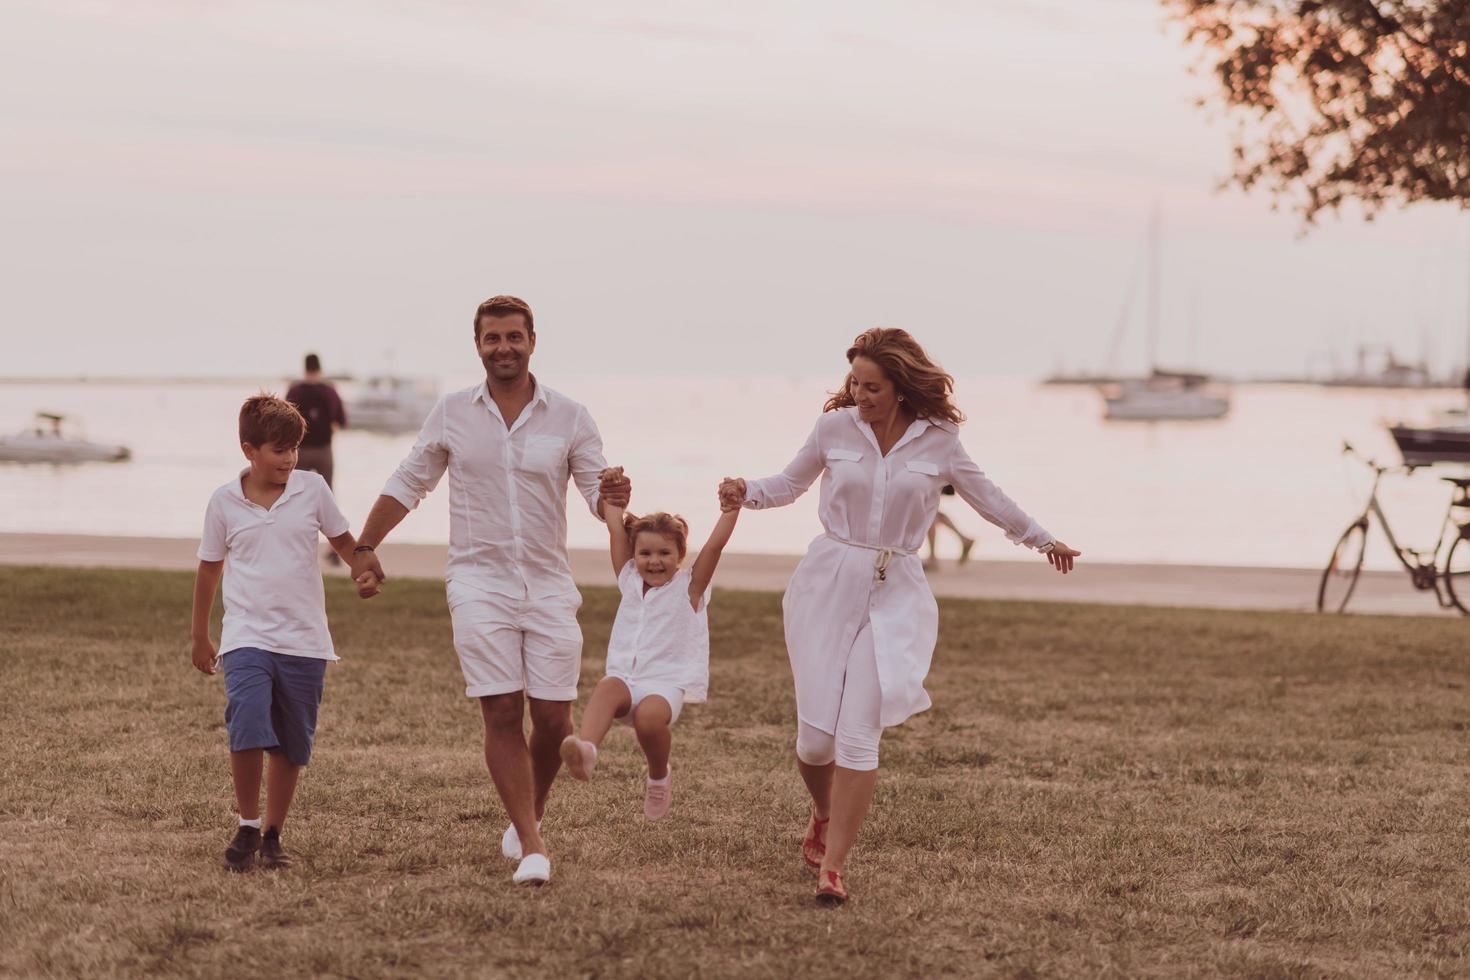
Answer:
[{"left": 1098, "top": 207, "right": 1230, "bottom": 422}]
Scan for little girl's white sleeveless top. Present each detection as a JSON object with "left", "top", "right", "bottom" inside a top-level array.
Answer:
[{"left": 607, "top": 560, "right": 713, "bottom": 704}]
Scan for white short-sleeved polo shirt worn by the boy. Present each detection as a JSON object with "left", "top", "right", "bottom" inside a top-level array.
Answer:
[{"left": 198, "top": 470, "right": 348, "bottom": 660}]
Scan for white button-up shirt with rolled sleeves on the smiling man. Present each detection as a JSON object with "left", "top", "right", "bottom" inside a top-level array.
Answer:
[{"left": 382, "top": 379, "right": 607, "bottom": 598}]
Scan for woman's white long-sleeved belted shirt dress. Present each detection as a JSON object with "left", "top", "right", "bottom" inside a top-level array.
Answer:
[{"left": 746, "top": 407, "right": 1054, "bottom": 733}]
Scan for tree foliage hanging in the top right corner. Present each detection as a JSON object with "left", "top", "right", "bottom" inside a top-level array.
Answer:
[{"left": 1163, "top": 0, "right": 1470, "bottom": 222}]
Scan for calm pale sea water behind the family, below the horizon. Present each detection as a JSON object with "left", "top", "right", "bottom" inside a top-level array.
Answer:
[{"left": 0, "top": 376, "right": 1460, "bottom": 567}]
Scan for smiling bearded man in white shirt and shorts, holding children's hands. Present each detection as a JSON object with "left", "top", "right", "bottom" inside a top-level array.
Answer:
[{"left": 353, "top": 295, "right": 631, "bottom": 884}]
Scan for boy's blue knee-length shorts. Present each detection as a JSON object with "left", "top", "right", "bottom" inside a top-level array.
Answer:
[{"left": 219, "top": 646, "right": 326, "bottom": 765}]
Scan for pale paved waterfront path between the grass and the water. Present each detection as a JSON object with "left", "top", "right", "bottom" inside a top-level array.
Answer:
[{"left": 0, "top": 533, "right": 1449, "bottom": 616}]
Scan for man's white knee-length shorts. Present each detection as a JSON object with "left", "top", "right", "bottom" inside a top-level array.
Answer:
[{"left": 448, "top": 582, "right": 582, "bottom": 701}]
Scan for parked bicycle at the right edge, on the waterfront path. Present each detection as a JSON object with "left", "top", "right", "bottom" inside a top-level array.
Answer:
[{"left": 1317, "top": 442, "right": 1470, "bottom": 616}]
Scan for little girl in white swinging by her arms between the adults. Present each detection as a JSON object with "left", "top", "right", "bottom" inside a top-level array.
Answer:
[{"left": 562, "top": 490, "right": 739, "bottom": 820}]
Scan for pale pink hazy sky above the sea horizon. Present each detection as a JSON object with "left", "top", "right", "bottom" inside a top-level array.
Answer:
[{"left": 0, "top": 0, "right": 1470, "bottom": 376}]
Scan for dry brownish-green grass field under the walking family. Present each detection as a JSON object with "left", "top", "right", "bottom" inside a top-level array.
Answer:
[{"left": 0, "top": 567, "right": 1470, "bottom": 977}]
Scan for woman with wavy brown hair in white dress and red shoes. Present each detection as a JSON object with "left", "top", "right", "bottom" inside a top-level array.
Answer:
[{"left": 720, "top": 329, "right": 1080, "bottom": 905}]
